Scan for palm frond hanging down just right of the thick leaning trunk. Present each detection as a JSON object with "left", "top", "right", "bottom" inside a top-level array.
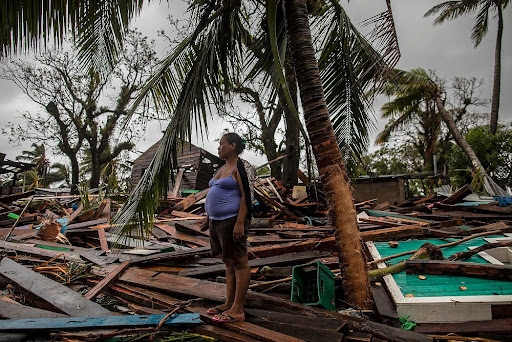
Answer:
[{"left": 313, "top": 6, "right": 390, "bottom": 155}]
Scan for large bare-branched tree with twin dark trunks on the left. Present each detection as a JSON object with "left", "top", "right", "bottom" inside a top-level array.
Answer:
[{"left": 0, "top": 31, "right": 156, "bottom": 187}]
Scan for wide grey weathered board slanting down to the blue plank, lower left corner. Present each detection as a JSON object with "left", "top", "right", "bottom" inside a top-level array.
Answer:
[{"left": 0, "top": 258, "right": 111, "bottom": 316}]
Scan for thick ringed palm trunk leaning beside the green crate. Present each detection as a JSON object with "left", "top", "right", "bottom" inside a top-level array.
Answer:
[{"left": 285, "top": 0, "right": 372, "bottom": 309}]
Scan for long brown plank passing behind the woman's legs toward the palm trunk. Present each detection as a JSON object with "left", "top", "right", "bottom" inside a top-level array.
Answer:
[{"left": 179, "top": 251, "right": 331, "bottom": 277}]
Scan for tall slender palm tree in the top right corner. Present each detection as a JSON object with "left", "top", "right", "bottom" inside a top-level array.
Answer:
[{"left": 425, "top": 0, "right": 510, "bottom": 134}]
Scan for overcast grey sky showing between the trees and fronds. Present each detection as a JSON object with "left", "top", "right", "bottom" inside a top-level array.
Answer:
[{"left": 0, "top": 0, "right": 512, "bottom": 165}]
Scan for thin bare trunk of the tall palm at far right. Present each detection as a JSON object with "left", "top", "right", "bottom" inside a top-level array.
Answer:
[{"left": 489, "top": 4, "right": 503, "bottom": 134}]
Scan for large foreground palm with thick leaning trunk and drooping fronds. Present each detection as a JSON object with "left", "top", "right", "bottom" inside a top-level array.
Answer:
[{"left": 0, "top": 0, "right": 396, "bottom": 308}]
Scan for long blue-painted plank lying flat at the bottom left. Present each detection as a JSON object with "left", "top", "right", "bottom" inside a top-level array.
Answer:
[{"left": 0, "top": 313, "right": 202, "bottom": 332}]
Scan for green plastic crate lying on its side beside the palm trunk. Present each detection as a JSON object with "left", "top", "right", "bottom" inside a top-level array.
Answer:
[{"left": 291, "top": 261, "right": 336, "bottom": 311}]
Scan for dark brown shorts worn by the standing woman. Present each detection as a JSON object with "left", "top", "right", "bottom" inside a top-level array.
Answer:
[{"left": 209, "top": 216, "right": 250, "bottom": 259}]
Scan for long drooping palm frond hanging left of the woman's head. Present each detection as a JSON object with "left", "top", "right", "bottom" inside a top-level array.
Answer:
[{"left": 113, "top": 0, "right": 247, "bottom": 237}]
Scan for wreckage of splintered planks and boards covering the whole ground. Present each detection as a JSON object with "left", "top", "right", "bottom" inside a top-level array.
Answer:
[{"left": 0, "top": 178, "right": 512, "bottom": 342}]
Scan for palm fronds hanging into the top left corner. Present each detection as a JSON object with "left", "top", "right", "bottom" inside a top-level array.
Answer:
[{"left": 0, "top": 0, "right": 144, "bottom": 73}]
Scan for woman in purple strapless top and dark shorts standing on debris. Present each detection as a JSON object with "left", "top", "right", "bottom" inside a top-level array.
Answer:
[{"left": 205, "top": 133, "right": 251, "bottom": 322}]
